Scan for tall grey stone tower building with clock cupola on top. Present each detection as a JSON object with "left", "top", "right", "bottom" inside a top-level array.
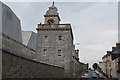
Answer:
[{"left": 36, "top": 2, "right": 80, "bottom": 77}]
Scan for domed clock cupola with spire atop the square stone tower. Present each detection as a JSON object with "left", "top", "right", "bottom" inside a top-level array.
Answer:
[{"left": 44, "top": 2, "right": 60, "bottom": 24}]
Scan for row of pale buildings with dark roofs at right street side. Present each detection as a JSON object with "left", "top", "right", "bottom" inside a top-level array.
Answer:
[{"left": 100, "top": 43, "right": 120, "bottom": 78}]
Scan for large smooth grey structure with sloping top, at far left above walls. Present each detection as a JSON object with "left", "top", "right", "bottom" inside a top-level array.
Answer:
[{"left": 0, "top": 3, "right": 22, "bottom": 43}]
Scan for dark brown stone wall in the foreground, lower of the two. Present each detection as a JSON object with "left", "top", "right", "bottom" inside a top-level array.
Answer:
[{"left": 2, "top": 51, "right": 64, "bottom": 78}]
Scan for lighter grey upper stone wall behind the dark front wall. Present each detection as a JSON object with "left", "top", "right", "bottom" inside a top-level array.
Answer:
[{"left": 0, "top": 34, "right": 35, "bottom": 60}]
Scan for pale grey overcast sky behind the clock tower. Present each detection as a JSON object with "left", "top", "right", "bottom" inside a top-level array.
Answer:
[{"left": 4, "top": 2, "right": 118, "bottom": 66}]
